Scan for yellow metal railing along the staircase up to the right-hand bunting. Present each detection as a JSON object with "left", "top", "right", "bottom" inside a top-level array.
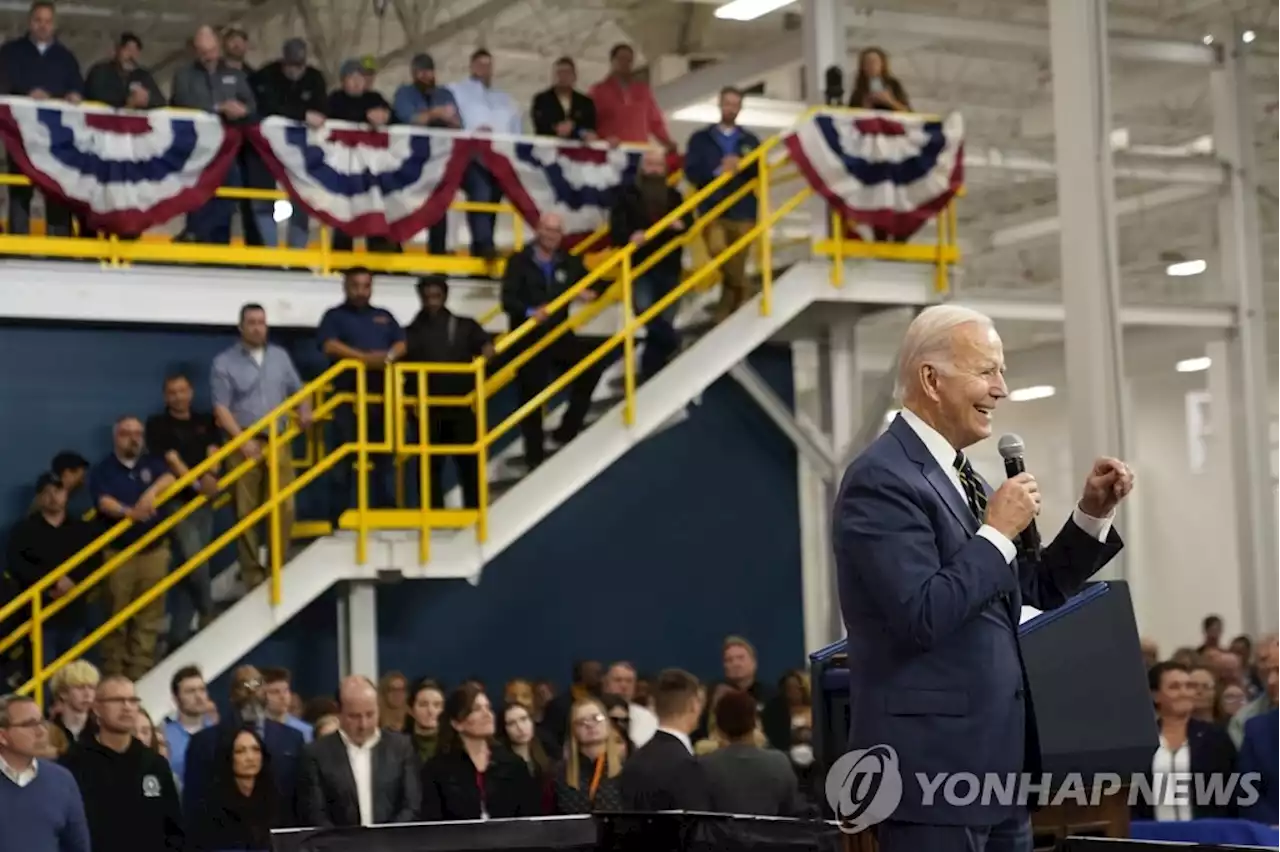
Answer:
[{"left": 10, "top": 106, "right": 959, "bottom": 697}]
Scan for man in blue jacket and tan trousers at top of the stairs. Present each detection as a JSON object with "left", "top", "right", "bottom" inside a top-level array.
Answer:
[{"left": 685, "top": 86, "right": 760, "bottom": 322}]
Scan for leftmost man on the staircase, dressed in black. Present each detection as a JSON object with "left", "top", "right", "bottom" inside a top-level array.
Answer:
[{"left": 5, "top": 473, "right": 101, "bottom": 665}]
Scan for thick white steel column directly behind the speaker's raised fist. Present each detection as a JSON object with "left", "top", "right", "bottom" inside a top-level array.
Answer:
[{"left": 1050, "top": 0, "right": 1126, "bottom": 578}]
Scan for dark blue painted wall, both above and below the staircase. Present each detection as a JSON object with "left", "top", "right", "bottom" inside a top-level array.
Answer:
[{"left": 0, "top": 325, "right": 803, "bottom": 696}]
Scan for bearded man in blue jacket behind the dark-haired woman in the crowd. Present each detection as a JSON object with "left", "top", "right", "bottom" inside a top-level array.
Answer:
[{"left": 183, "top": 665, "right": 306, "bottom": 818}]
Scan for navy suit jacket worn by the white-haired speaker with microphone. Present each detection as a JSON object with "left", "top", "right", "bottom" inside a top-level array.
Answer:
[{"left": 832, "top": 414, "right": 1123, "bottom": 825}]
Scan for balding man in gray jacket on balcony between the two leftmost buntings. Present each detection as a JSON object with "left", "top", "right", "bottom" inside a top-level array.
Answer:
[{"left": 170, "top": 27, "right": 257, "bottom": 246}]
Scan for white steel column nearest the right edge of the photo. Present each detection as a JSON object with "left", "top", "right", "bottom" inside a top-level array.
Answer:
[{"left": 1210, "top": 32, "right": 1280, "bottom": 633}]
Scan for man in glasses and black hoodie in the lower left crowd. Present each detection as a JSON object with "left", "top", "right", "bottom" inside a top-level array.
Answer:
[{"left": 60, "top": 674, "right": 186, "bottom": 852}]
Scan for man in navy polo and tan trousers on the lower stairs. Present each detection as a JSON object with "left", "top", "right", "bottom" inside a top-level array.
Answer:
[{"left": 88, "top": 417, "right": 174, "bottom": 681}]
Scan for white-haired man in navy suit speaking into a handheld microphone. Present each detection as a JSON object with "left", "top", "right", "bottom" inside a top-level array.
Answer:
[{"left": 832, "top": 304, "right": 1133, "bottom": 852}]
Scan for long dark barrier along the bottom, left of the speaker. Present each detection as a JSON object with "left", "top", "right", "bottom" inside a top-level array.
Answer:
[{"left": 271, "top": 812, "right": 844, "bottom": 852}]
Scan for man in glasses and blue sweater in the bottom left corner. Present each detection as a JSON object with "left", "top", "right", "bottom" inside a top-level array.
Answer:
[{"left": 0, "top": 695, "right": 90, "bottom": 852}]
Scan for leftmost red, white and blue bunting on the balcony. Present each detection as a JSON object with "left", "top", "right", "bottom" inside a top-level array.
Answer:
[{"left": 0, "top": 97, "right": 241, "bottom": 234}]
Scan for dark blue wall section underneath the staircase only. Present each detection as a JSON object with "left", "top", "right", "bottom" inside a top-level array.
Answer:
[{"left": 212, "top": 348, "right": 804, "bottom": 696}]
